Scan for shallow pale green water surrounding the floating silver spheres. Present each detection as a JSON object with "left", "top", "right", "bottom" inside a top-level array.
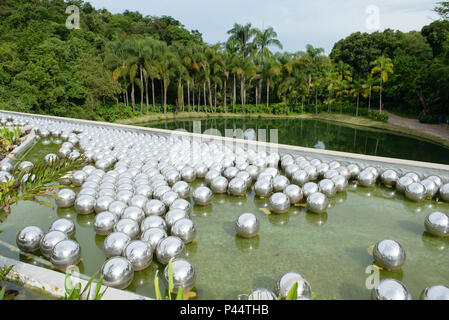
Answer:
[{"left": 0, "top": 142, "right": 449, "bottom": 300}]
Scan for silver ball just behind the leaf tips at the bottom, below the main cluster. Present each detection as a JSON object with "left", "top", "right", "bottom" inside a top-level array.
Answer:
[{"left": 164, "top": 258, "right": 196, "bottom": 293}]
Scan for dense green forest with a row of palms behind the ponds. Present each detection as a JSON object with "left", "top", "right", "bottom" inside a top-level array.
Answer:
[{"left": 0, "top": 0, "right": 449, "bottom": 122}]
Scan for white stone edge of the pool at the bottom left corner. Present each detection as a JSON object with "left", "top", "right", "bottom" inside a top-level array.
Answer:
[{"left": 0, "top": 255, "right": 153, "bottom": 300}]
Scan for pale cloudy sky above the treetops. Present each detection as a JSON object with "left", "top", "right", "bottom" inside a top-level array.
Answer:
[{"left": 89, "top": 0, "right": 438, "bottom": 54}]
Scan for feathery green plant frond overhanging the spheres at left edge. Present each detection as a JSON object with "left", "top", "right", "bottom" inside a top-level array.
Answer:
[{"left": 0, "top": 158, "right": 84, "bottom": 222}]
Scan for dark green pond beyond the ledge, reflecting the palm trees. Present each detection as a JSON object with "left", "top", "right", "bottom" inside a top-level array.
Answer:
[{"left": 136, "top": 118, "right": 449, "bottom": 164}]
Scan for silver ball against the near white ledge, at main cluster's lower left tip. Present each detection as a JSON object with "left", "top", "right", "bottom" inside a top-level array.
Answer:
[{"left": 101, "top": 257, "right": 134, "bottom": 289}]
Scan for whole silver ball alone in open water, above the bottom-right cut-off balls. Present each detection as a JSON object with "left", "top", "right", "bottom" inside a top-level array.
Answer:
[{"left": 373, "top": 239, "right": 406, "bottom": 270}]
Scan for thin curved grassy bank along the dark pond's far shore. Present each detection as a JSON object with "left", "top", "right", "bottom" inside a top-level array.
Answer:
[{"left": 116, "top": 112, "right": 449, "bottom": 148}]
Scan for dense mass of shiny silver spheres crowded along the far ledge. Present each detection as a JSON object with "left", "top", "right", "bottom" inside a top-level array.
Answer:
[{"left": 0, "top": 110, "right": 449, "bottom": 298}]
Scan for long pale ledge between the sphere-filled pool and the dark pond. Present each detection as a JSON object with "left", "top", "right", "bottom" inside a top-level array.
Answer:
[{"left": 0, "top": 110, "right": 449, "bottom": 182}]
